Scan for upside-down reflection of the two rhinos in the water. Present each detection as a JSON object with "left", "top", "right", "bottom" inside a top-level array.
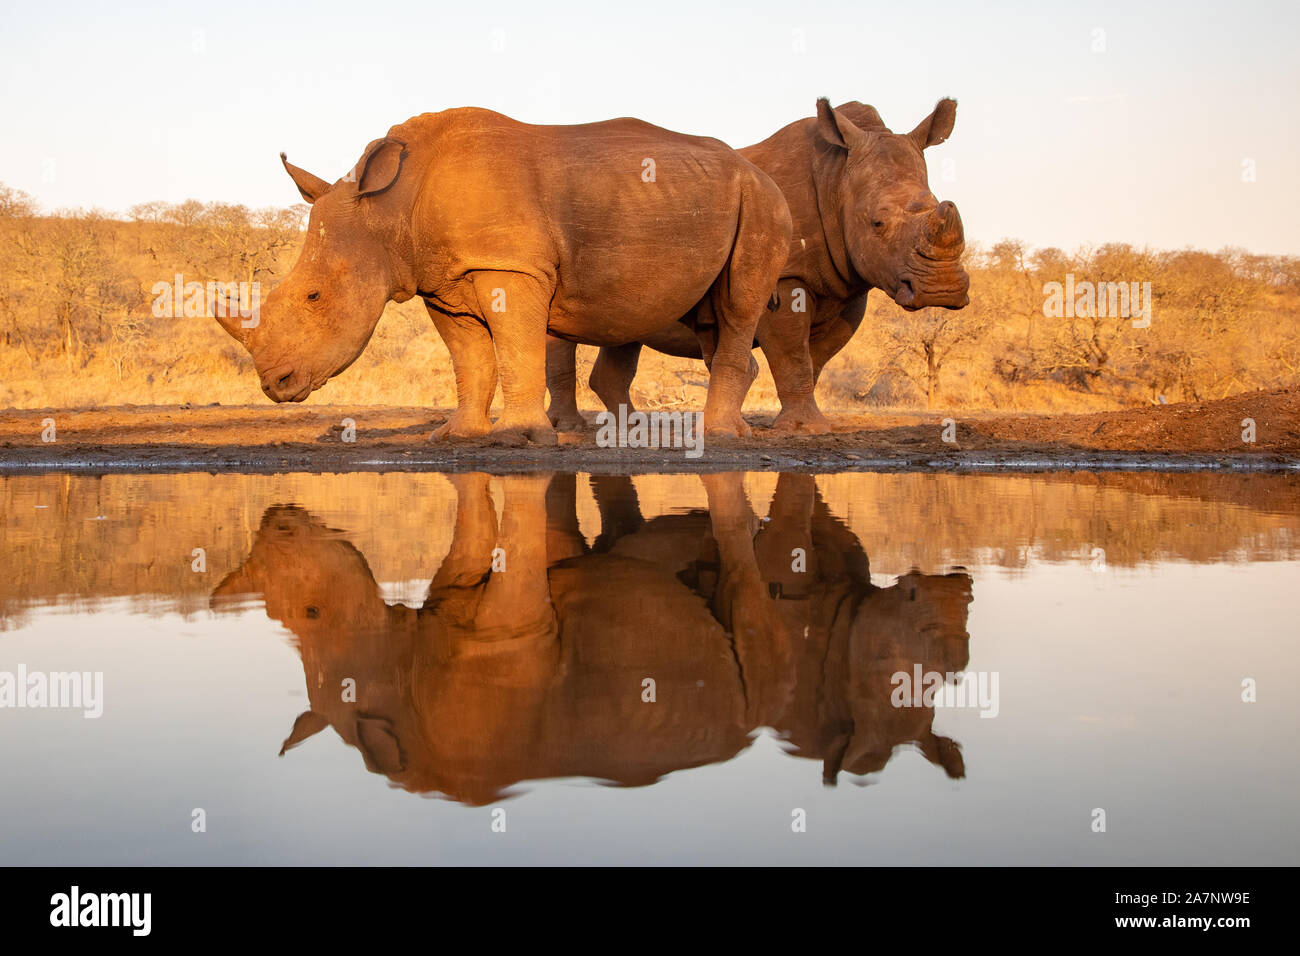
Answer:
[{"left": 213, "top": 475, "right": 971, "bottom": 804}]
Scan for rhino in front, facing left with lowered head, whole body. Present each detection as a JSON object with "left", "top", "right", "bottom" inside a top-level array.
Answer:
[{"left": 220, "top": 109, "right": 790, "bottom": 442}]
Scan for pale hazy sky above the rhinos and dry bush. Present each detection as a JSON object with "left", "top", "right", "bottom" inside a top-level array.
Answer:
[{"left": 0, "top": 0, "right": 1300, "bottom": 255}]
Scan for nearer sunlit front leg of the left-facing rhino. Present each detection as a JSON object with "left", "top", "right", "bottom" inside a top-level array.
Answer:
[{"left": 472, "top": 272, "right": 559, "bottom": 445}]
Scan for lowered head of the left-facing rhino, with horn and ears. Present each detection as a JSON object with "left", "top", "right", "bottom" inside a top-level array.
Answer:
[{"left": 217, "top": 138, "right": 413, "bottom": 402}]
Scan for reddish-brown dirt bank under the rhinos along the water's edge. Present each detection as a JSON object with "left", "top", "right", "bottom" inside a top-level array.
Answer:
[{"left": 0, "top": 389, "right": 1300, "bottom": 473}]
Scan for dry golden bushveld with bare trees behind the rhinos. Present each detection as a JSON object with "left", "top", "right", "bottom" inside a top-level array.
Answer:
[{"left": 0, "top": 185, "right": 1300, "bottom": 411}]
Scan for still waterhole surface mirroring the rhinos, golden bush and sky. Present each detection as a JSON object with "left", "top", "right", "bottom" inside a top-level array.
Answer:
[{"left": 0, "top": 473, "right": 1300, "bottom": 865}]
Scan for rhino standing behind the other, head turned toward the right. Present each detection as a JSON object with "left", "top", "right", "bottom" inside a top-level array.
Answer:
[{"left": 547, "top": 99, "right": 970, "bottom": 432}]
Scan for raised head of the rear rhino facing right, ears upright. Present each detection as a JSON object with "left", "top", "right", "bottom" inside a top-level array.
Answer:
[{"left": 814, "top": 98, "right": 970, "bottom": 311}]
